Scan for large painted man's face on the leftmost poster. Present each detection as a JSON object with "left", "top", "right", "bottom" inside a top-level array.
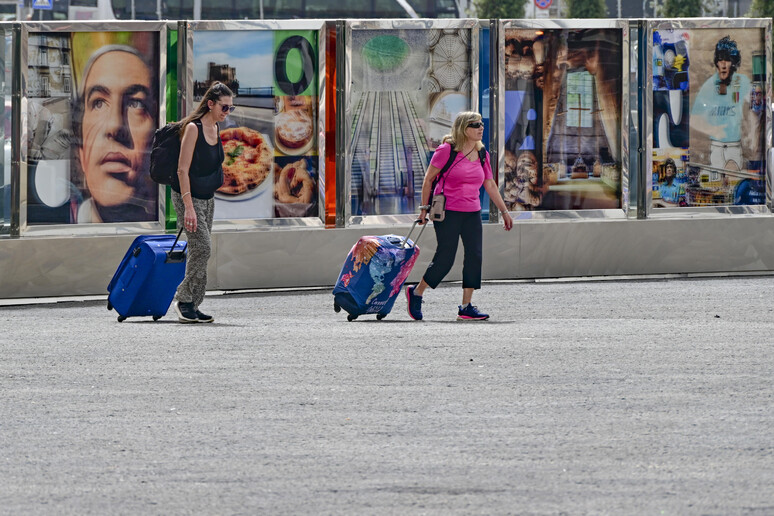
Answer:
[{"left": 78, "top": 50, "right": 155, "bottom": 207}]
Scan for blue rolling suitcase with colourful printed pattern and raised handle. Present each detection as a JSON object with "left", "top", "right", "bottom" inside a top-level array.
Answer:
[{"left": 333, "top": 221, "right": 427, "bottom": 321}]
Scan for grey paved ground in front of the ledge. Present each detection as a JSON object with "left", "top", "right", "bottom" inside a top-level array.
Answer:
[{"left": 0, "top": 277, "right": 774, "bottom": 515}]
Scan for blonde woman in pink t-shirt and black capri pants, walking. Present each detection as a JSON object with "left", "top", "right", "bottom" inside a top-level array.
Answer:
[{"left": 406, "top": 111, "right": 513, "bottom": 321}]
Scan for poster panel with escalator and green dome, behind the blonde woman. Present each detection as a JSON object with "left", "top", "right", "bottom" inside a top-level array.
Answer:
[{"left": 345, "top": 23, "right": 477, "bottom": 216}]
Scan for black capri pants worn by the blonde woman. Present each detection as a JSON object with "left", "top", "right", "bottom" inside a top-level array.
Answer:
[{"left": 423, "top": 210, "right": 483, "bottom": 289}]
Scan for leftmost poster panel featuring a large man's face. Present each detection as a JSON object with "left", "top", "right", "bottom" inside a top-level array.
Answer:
[{"left": 23, "top": 31, "right": 161, "bottom": 225}]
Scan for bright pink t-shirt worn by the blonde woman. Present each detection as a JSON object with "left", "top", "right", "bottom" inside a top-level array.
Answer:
[{"left": 430, "top": 143, "right": 492, "bottom": 212}]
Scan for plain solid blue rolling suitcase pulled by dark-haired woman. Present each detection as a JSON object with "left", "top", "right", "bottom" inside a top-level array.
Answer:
[{"left": 108, "top": 229, "right": 186, "bottom": 322}]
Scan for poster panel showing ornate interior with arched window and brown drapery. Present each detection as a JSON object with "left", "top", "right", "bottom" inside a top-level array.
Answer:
[{"left": 501, "top": 27, "right": 628, "bottom": 211}]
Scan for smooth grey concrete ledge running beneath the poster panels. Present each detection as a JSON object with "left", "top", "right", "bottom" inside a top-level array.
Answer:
[{"left": 0, "top": 215, "right": 774, "bottom": 298}]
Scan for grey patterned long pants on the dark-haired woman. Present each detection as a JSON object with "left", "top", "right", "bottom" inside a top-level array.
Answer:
[{"left": 172, "top": 190, "right": 215, "bottom": 309}]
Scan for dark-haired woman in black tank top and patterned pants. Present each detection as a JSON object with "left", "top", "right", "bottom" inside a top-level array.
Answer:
[{"left": 172, "top": 82, "right": 234, "bottom": 323}]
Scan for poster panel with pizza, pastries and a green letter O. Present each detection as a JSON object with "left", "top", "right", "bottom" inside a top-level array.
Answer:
[{"left": 192, "top": 30, "right": 321, "bottom": 220}]
